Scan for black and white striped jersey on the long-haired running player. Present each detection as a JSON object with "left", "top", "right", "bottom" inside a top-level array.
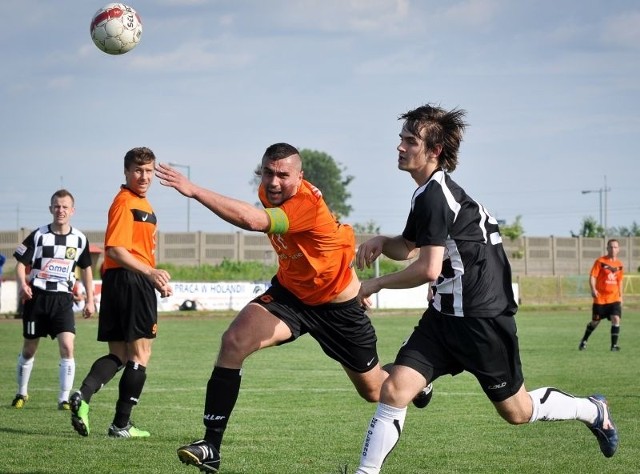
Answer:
[{"left": 402, "top": 170, "right": 517, "bottom": 318}]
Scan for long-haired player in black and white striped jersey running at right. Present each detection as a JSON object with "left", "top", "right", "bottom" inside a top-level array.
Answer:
[{"left": 356, "top": 104, "right": 618, "bottom": 474}]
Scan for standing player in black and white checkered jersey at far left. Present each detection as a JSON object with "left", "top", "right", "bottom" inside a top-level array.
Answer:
[{"left": 11, "top": 189, "right": 95, "bottom": 410}]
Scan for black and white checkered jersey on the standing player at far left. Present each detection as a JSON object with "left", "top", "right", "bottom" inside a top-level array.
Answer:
[{"left": 13, "top": 225, "right": 91, "bottom": 293}]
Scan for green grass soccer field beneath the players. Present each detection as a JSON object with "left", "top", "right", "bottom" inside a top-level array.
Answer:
[{"left": 0, "top": 311, "right": 640, "bottom": 474}]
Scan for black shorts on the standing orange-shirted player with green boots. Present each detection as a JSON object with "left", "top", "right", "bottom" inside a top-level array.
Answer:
[{"left": 98, "top": 268, "right": 158, "bottom": 342}]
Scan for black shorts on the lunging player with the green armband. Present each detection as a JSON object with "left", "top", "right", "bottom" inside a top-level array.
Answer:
[{"left": 252, "top": 278, "right": 378, "bottom": 373}]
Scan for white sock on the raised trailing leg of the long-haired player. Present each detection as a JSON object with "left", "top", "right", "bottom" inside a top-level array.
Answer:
[{"left": 529, "top": 387, "right": 598, "bottom": 425}]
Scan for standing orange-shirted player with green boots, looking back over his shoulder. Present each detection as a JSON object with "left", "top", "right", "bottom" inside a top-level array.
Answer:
[{"left": 69, "top": 147, "right": 171, "bottom": 438}]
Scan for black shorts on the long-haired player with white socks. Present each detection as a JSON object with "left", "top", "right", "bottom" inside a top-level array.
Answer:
[{"left": 395, "top": 308, "right": 524, "bottom": 402}]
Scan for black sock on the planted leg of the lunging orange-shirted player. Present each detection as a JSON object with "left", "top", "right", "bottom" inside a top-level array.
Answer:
[{"left": 203, "top": 367, "right": 242, "bottom": 451}]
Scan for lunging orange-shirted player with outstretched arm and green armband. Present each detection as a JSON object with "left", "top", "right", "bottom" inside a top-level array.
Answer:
[{"left": 156, "top": 143, "right": 432, "bottom": 472}]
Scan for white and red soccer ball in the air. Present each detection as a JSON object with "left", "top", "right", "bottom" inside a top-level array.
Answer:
[{"left": 91, "top": 3, "right": 142, "bottom": 54}]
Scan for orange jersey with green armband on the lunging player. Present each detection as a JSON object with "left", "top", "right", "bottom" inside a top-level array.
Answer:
[{"left": 258, "top": 180, "right": 356, "bottom": 305}]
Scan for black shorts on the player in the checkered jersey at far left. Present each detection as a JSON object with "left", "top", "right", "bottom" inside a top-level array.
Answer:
[{"left": 22, "top": 287, "right": 76, "bottom": 339}]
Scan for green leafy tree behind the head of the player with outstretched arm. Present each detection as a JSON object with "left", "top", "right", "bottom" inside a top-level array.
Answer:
[{"left": 252, "top": 149, "right": 354, "bottom": 219}]
